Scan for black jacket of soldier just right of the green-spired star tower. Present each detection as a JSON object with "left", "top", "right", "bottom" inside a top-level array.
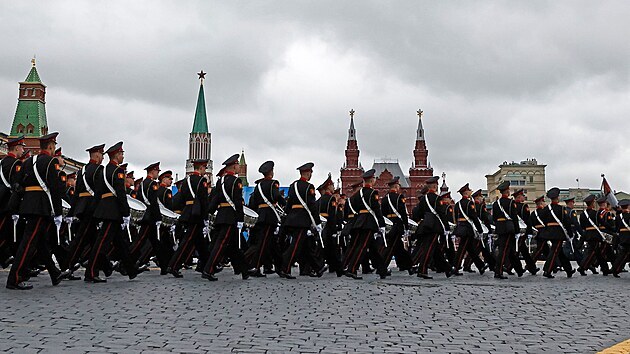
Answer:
[{"left": 210, "top": 174, "right": 244, "bottom": 225}]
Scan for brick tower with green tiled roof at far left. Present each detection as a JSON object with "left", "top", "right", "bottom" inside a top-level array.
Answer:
[{"left": 10, "top": 58, "right": 48, "bottom": 152}]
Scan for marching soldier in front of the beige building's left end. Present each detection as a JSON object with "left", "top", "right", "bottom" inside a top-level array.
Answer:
[{"left": 492, "top": 181, "right": 524, "bottom": 279}]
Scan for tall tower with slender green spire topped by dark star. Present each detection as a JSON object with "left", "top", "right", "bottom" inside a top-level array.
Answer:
[{"left": 186, "top": 70, "right": 212, "bottom": 181}]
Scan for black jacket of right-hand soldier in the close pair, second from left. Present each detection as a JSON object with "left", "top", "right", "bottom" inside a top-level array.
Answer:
[{"left": 88, "top": 162, "right": 129, "bottom": 223}]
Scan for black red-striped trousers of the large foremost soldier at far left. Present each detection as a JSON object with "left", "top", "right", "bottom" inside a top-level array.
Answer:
[{"left": 7, "top": 216, "right": 61, "bottom": 285}]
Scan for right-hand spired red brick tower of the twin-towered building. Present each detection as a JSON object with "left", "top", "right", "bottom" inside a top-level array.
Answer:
[{"left": 407, "top": 110, "right": 433, "bottom": 205}]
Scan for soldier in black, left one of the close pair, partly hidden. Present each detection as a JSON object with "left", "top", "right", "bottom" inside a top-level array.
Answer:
[{"left": 66, "top": 144, "right": 105, "bottom": 277}]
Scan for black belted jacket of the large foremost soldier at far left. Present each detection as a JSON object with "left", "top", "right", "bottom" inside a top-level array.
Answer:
[{"left": 20, "top": 153, "right": 63, "bottom": 216}]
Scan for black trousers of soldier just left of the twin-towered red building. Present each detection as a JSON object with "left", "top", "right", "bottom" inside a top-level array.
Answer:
[{"left": 281, "top": 228, "right": 323, "bottom": 274}]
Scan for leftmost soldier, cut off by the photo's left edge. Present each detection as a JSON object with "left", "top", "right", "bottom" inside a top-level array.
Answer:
[{"left": 0, "top": 136, "right": 24, "bottom": 268}]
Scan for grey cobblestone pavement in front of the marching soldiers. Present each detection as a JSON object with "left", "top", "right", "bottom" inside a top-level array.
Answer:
[{"left": 0, "top": 262, "right": 630, "bottom": 353}]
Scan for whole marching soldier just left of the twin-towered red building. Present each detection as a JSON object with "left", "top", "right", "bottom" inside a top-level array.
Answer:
[{"left": 278, "top": 162, "right": 326, "bottom": 279}]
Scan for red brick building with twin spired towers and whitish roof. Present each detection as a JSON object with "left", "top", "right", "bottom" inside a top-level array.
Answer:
[{"left": 341, "top": 110, "right": 433, "bottom": 211}]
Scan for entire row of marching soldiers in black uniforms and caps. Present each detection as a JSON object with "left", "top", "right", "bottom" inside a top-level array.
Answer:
[{"left": 0, "top": 133, "right": 630, "bottom": 289}]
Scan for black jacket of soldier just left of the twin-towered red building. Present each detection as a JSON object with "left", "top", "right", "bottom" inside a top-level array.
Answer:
[{"left": 284, "top": 179, "right": 321, "bottom": 229}]
